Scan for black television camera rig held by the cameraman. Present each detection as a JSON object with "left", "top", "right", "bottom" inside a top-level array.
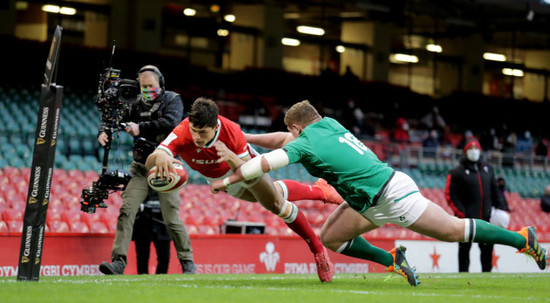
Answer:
[{"left": 80, "top": 46, "right": 139, "bottom": 214}]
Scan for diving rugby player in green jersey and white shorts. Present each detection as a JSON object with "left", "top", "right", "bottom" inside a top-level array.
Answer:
[{"left": 212, "top": 101, "right": 547, "bottom": 286}]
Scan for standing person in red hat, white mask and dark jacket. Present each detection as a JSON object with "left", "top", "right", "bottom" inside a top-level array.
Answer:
[{"left": 445, "top": 138, "right": 507, "bottom": 272}]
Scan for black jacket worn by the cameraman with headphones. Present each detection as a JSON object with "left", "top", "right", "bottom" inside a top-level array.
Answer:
[{"left": 100, "top": 91, "right": 184, "bottom": 163}]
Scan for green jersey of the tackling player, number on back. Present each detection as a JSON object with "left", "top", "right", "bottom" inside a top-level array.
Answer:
[{"left": 284, "top": 118, "right": 393, "bottom": 212}]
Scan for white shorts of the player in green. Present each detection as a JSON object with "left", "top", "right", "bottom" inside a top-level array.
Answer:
[{"left": 361, "top": 171, "right": 430, "bottom": 227}]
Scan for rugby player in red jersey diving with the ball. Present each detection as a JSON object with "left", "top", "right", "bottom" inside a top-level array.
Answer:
[{"left": 146, "top": 98, "right": 336, "bottom": 282}]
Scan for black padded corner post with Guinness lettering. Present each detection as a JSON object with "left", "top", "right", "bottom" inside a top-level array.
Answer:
[{"left": 17, "top": 26, "right": 63, "bottom": 281}]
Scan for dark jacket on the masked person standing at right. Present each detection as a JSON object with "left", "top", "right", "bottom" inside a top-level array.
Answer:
[{"left": 445, "top": 158, "right": 505, "bottom": 221}]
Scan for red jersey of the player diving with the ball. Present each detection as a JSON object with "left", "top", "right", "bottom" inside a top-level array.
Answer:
[{"left": 158, "top": 116, "right": 249, "bottom": 178}]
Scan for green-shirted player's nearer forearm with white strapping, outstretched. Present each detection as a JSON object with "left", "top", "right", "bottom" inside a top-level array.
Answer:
[{"left": 212, "top": 149, "right": 289, "bottom": 193}]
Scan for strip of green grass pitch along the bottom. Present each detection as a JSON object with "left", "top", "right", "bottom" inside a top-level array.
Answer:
[{"left": 0, "top": 273, "right": 550, "bottom": 303}]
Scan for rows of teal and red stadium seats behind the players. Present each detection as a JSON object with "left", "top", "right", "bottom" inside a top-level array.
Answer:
[{"left": 0, "top": 86, "right": 550, "bottom": 245}]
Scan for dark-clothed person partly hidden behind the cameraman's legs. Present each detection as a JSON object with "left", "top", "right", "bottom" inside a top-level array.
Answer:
[{"left": 132, "top": 190, "right": 172, "bottom": 275}]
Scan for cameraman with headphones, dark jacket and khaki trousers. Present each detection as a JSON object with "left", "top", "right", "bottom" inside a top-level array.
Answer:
[{"left": 98, "top": 65, "right": 196, "bottom": 275}]
